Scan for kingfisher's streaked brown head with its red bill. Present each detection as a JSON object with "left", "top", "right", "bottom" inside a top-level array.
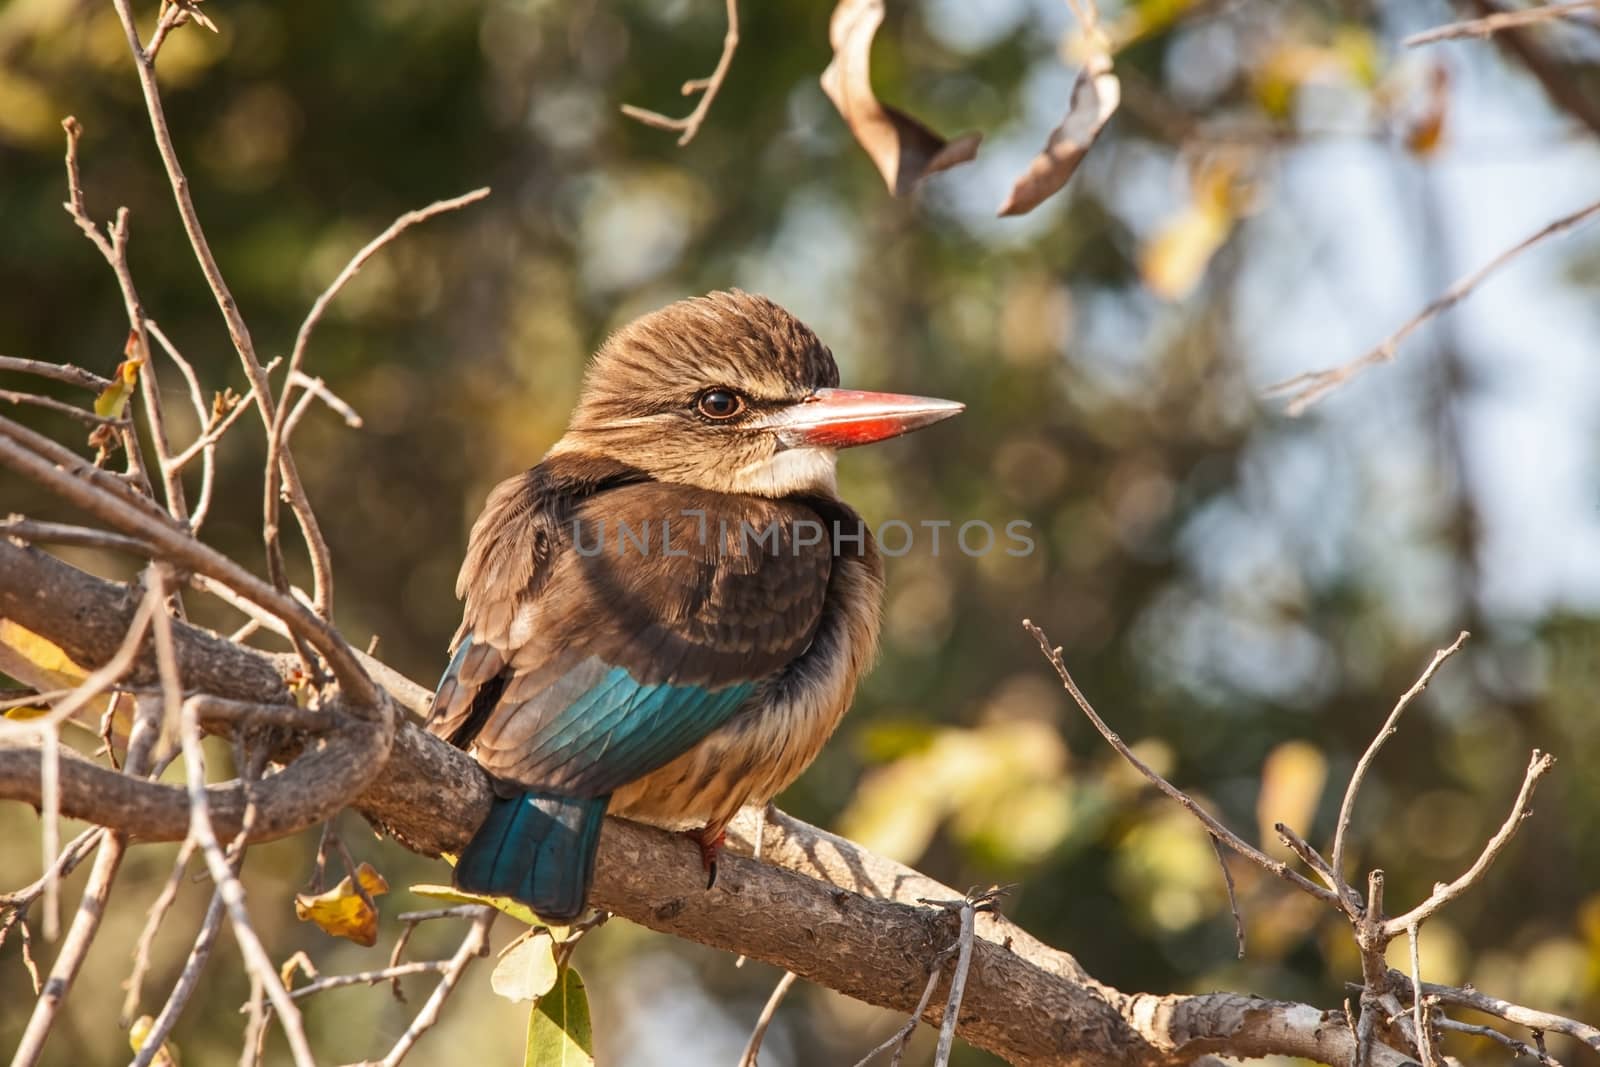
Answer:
[{"left": 552, "top": 291, "right": 963, "bottom": 498}]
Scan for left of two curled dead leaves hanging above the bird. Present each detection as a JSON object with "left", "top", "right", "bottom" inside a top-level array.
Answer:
[{"left": 822, "top": 0, "right": 982, "bottom": 197}]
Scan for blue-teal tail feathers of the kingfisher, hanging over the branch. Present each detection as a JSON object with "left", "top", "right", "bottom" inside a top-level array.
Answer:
[{"left": 456, "top": 792, "right": 611, "bottom": 920}]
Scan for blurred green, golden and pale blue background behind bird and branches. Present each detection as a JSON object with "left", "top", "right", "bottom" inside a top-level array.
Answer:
[{"left": 0, "top": 0, "right": 1600, "bottom": 1067}]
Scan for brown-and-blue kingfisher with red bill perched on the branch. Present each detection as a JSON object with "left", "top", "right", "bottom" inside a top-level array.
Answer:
[{"left": 427, "top": 290, "right": 963, "bottom": 921}]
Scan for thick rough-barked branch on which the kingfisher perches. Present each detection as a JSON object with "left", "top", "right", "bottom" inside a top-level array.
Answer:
[{"left": 0, "top": 544, "right": 1410, "bottom": 1067}]
